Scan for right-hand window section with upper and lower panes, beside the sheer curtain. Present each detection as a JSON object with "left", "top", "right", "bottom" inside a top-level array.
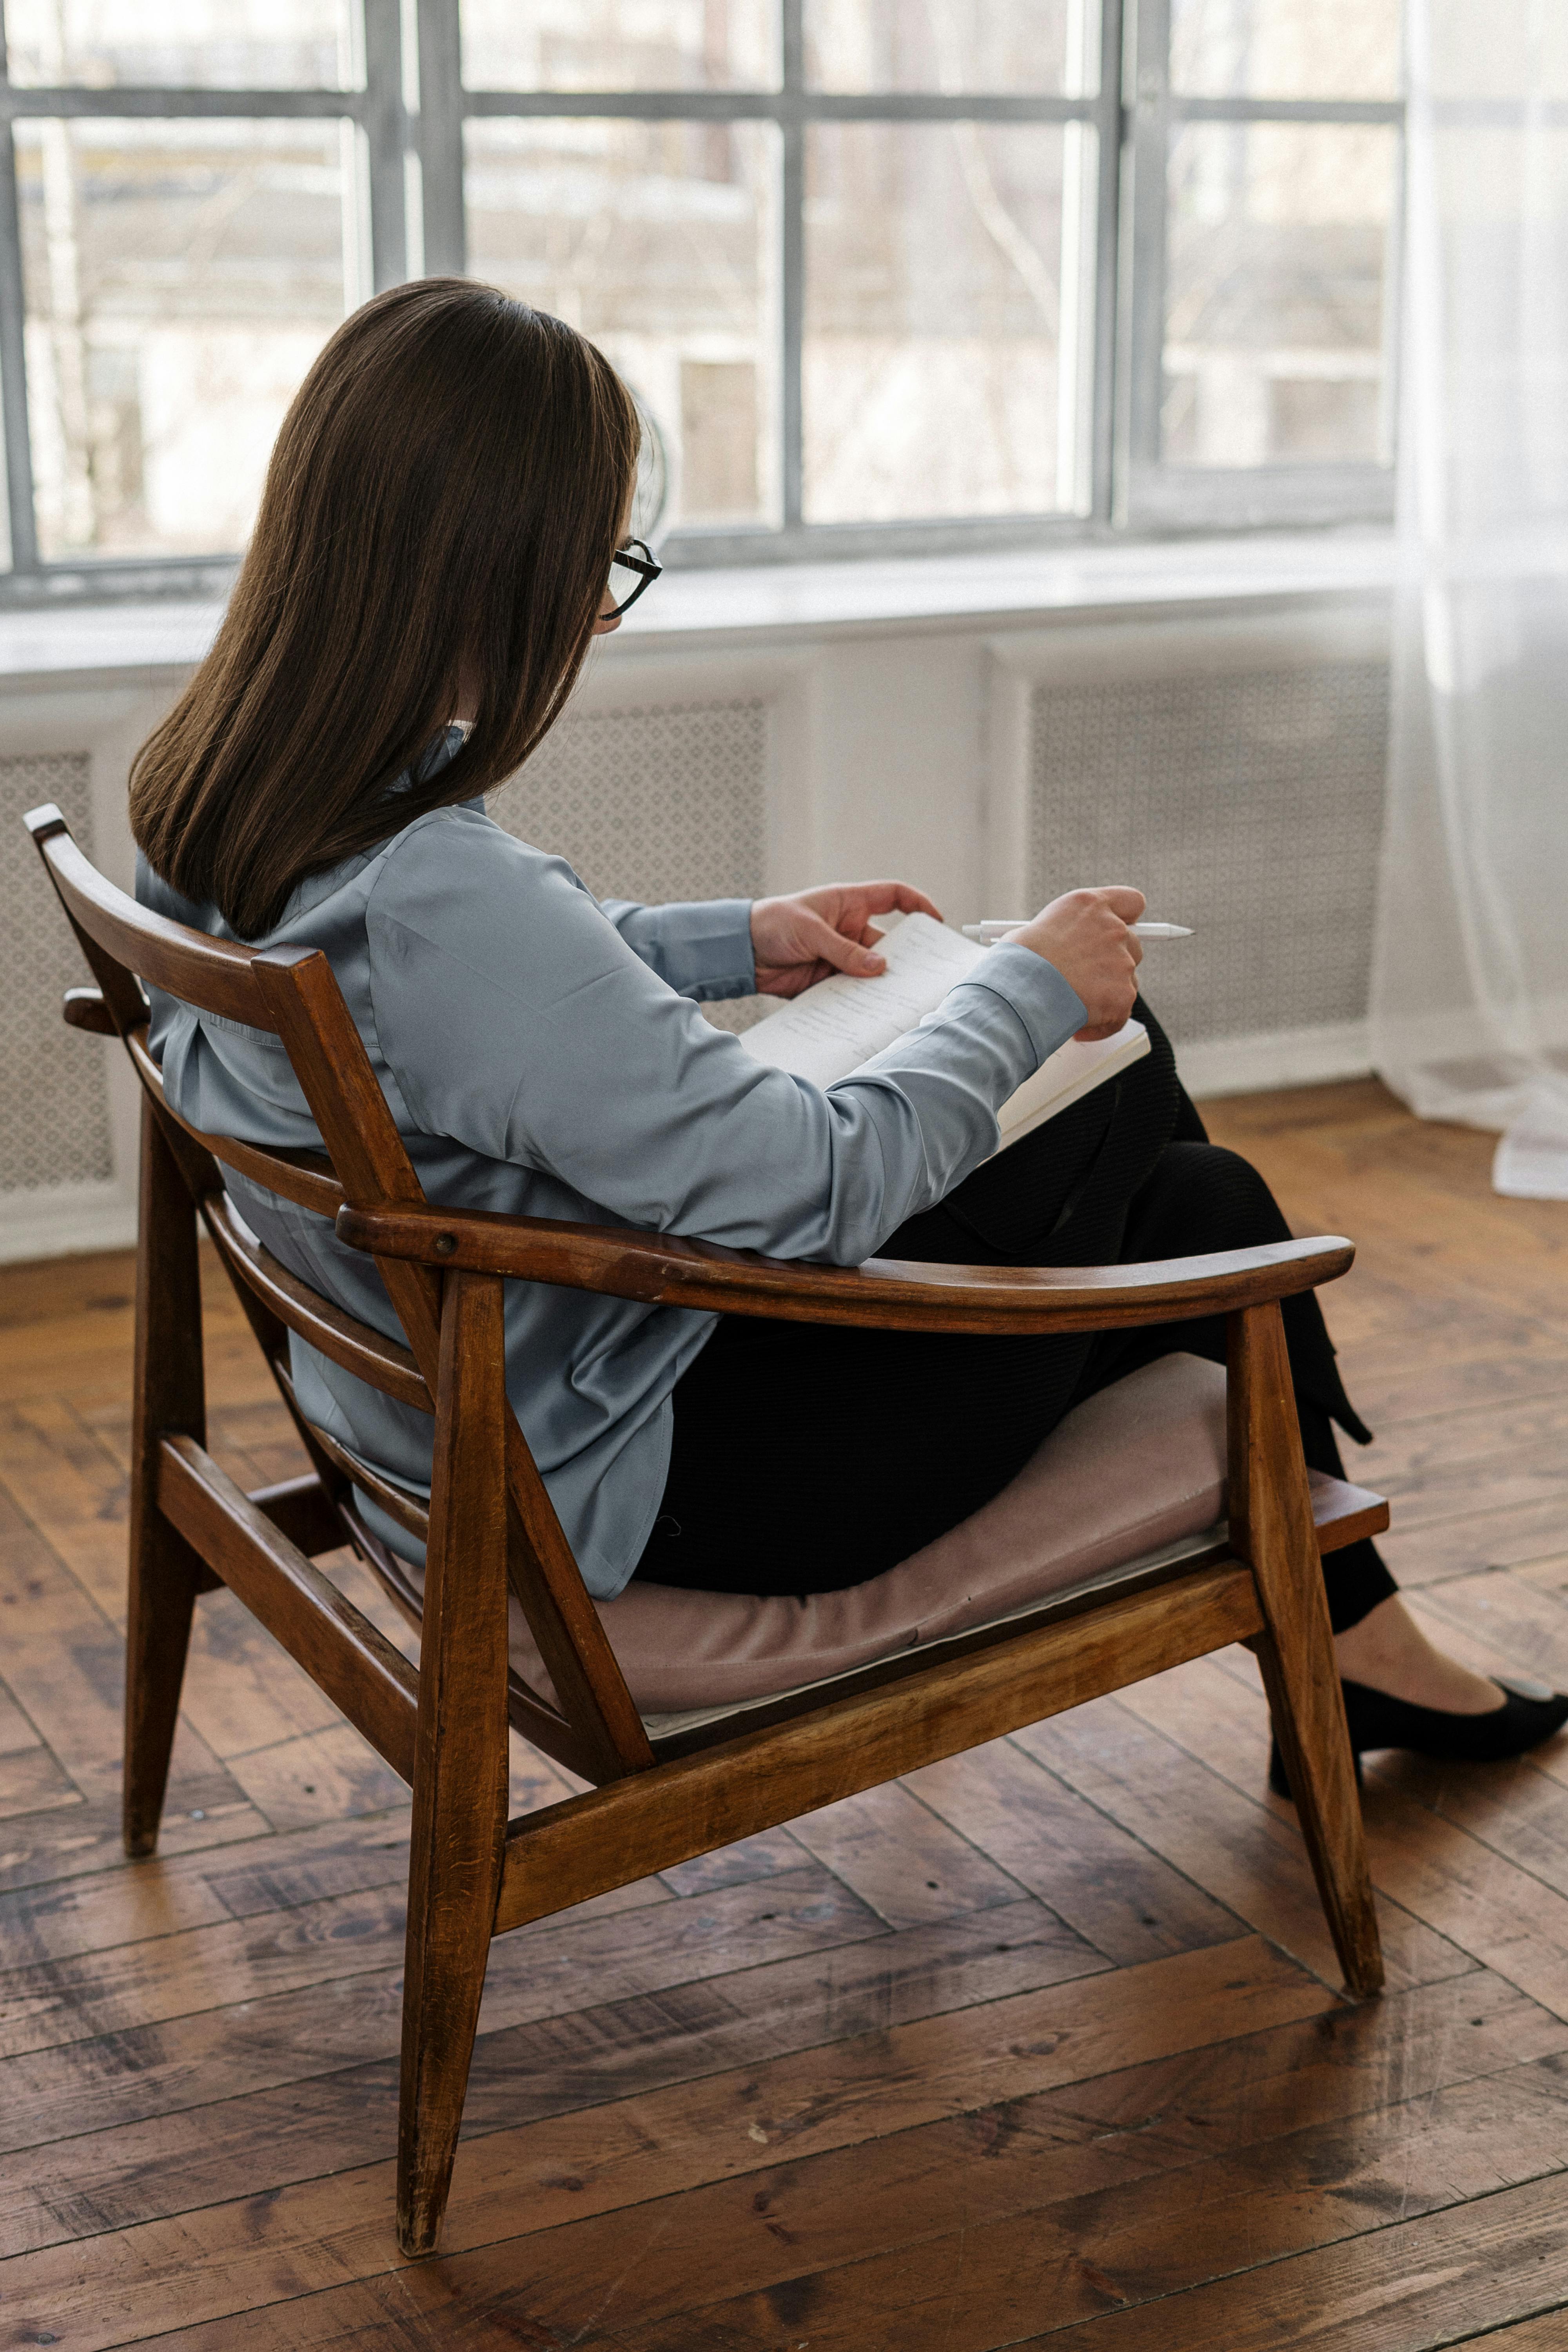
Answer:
[{"left": 1117, "top": 0, "right": 1403, "bottom": 522}]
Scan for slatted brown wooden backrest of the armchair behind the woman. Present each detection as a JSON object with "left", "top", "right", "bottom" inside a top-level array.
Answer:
[{"left": 26, "top": 804, "right": 651, "bottom": 1780}]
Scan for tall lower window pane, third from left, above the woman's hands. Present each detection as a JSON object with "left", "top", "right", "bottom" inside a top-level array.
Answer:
[{"left": 804, "top": 122, "right": 1072, "bottom": 522}]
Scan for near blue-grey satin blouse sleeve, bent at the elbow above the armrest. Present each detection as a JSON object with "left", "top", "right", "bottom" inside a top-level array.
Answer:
[{"left": 367, "top": 809, "right": 1084, "bottom": 1265}]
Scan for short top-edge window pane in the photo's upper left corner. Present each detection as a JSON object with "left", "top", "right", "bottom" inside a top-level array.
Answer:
[{"left": 5, "top": 0, "right": 365, "bottom": 89}]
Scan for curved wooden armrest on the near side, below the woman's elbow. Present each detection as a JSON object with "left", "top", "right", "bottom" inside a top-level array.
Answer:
[{"left": 336, "top": 1202, "right": 1354, "bottom": 1334}]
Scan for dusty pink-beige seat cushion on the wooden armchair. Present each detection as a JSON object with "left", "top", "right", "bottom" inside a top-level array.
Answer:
[{"left": 510, "top": 1355, "right": 1225, "bottom": 1715}]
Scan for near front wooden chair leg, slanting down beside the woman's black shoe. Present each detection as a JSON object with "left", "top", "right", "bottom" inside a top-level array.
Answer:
[{"left": 1229, "top": 1303, "right": 1382, "bottom": 1997}]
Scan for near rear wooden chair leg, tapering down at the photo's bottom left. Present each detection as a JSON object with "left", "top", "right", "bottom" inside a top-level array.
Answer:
[{"left": 397, "top": 1275, "right": 508, "bottom": 2256}]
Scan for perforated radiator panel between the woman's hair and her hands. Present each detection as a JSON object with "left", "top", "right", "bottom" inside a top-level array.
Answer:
[{"left": 489, "top": 701, "right": 766, "bottom": 1028}]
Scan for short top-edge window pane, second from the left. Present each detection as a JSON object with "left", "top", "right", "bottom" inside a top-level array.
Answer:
[{"left": 463, "top": 0, "right": 778, "bottom": 89}]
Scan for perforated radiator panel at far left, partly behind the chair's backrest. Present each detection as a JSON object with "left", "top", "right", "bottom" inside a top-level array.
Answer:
[{"left": 0, "top": 750, "right": 113, "bottom": 1192}]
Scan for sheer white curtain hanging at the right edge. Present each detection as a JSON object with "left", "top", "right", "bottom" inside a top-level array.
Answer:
[{"left": 1370, "top": 0, "right": 1568, "bottom": 1200}]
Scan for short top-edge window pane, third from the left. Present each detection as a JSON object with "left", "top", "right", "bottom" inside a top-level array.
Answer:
[{"left": 804, "top": 0, "right": 1081, "bottom": 96}]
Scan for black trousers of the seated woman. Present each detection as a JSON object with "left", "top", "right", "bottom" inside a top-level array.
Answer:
[{"left": 637, "top": 1004, "right": 1396, "bottom": 1632}]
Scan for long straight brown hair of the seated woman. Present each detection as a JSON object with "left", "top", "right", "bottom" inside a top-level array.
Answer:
[{"left": 132, "top": 278, "right": 637, "bottom": 938}]
